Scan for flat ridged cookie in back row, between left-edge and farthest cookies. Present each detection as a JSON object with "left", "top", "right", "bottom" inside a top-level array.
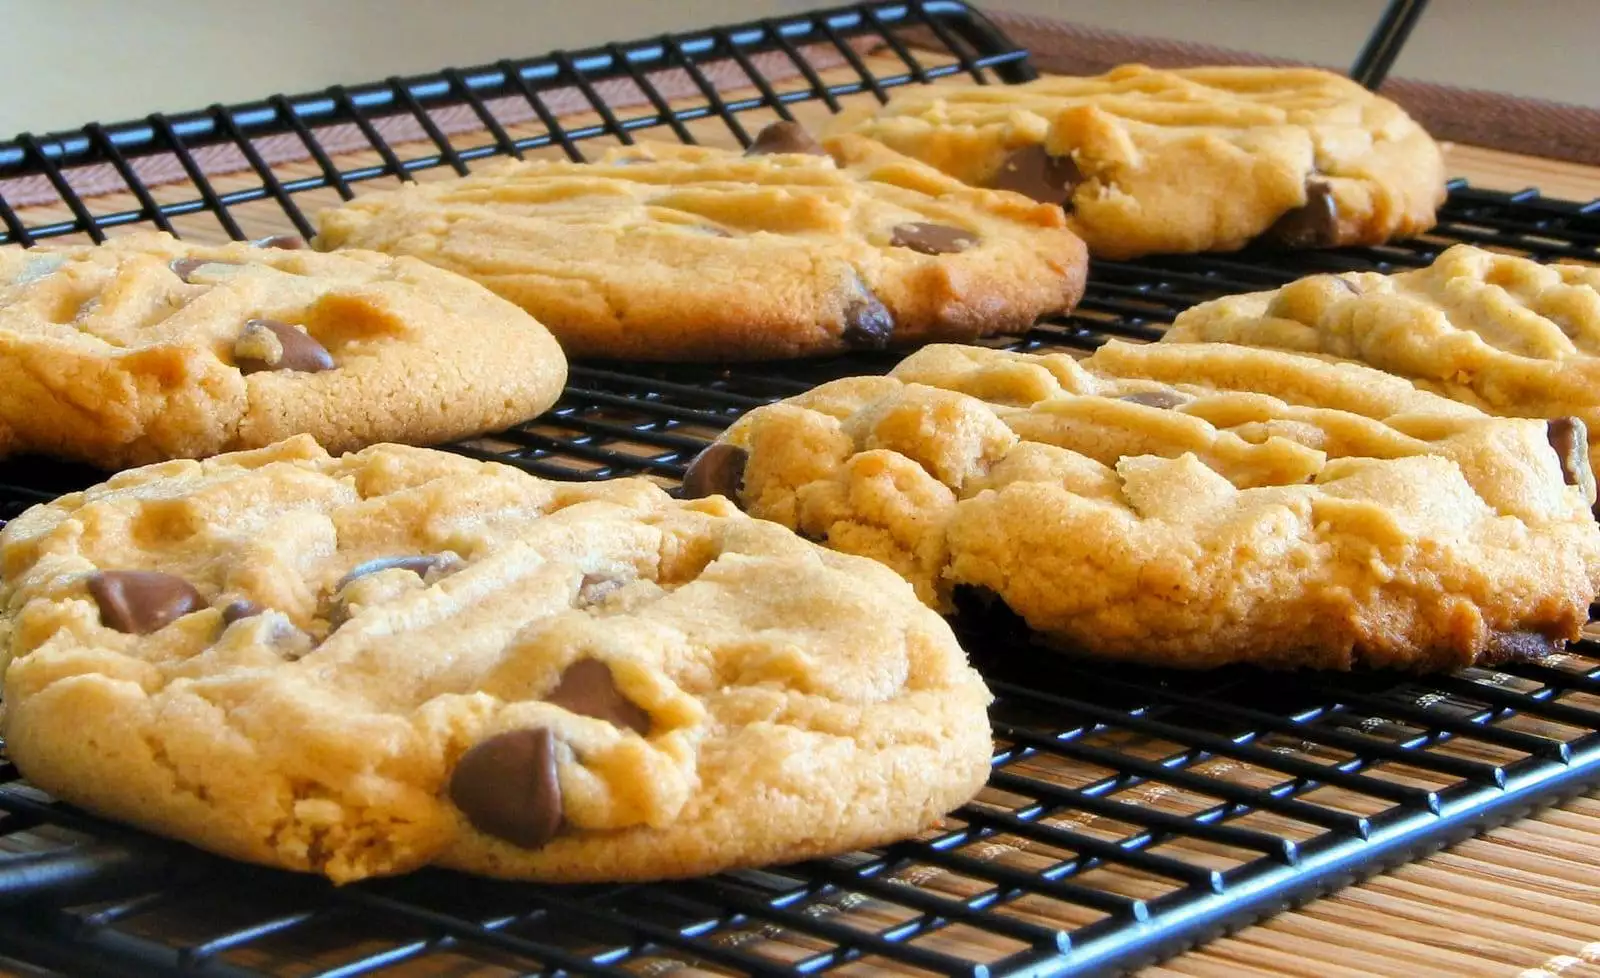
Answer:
[{"left": 315, "top": 123, "right": 1085, "bottom": 360}]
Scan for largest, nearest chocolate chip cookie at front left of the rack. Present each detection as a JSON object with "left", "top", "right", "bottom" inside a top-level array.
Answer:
[{"left": 0, "top": 437, "right": 992, "bottom": 882}]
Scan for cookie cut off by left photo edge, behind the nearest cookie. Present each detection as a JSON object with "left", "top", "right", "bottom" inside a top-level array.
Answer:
[{"left": 0, "top": 232, "right": 566, "bottom": 467}]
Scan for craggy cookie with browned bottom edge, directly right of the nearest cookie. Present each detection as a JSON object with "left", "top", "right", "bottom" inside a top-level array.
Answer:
[{"left": 688, "top": 341, "right": 1600, "bottom": 669}]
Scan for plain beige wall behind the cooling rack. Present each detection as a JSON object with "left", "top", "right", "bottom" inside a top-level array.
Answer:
[{"left": 0, "top": 0, "right": 1600, "bottom": 139}]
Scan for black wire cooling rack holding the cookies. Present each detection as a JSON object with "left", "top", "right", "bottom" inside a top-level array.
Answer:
[{"left": 0, "top": 0, "right": 1600, "bottom": 976}]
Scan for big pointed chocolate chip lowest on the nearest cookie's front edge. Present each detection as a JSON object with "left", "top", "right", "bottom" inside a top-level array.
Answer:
[{"left": 450, "top": 727, "right": 562, "bottom": 848}]
